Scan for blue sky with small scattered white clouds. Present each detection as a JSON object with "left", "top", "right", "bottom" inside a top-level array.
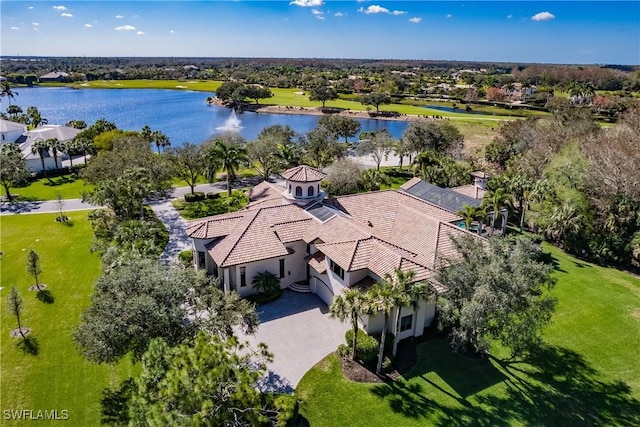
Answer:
[{"left": 0, "top": 0, "right": 640, "bottom": 65}]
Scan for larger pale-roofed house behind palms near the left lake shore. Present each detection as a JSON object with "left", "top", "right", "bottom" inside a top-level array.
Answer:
[{"left": 16, "top": 125, "right": 80, "bottom": 172}]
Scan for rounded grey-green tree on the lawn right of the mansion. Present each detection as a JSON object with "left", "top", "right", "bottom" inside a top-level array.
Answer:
[{"left": 438, "top": 236, "right": 556, "bottom": 356}]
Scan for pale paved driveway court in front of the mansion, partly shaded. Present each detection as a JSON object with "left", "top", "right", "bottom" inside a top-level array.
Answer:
[{"left": 244, "top": 289, "right": 349, "bottom": 392}]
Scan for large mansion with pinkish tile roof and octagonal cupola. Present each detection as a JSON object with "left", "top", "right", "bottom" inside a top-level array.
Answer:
[{"left": 187, "top": 166, "right": 482, "bottom": 339}]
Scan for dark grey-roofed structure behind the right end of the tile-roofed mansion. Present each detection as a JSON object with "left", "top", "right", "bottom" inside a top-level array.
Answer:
[{"left": 400, "top": 172, "right": 508, "bottom": 235}]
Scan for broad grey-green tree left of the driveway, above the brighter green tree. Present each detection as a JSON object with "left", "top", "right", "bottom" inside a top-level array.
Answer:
[{"left": 74, "top": 256, "right": 258, "bottom": 363}]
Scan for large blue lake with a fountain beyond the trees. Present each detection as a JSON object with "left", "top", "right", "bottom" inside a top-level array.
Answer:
[{"left": 0, "top": 87, "right": 407, "bottom": 146}]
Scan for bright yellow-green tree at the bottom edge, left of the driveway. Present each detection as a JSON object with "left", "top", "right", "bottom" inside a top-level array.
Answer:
[{"left": 127, "top": 334, "right": 294, "bottom": 427}]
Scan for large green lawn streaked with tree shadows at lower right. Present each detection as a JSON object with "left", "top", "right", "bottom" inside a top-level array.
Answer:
[{"left": 296, "top": 242, "right": 640, "bottom": 427}]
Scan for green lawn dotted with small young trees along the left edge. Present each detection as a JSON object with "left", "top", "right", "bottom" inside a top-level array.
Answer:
[{"left": 0, "top": 212, "right": 132, "bottom": 426}]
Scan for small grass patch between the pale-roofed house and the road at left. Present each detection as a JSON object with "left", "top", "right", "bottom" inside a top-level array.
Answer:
[{"left": 11, "top": 174, "right": 91, "bottom": 201}]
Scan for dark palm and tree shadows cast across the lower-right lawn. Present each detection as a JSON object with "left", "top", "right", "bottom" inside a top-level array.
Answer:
[{"left": 372, "top": 342, "right": 640, "bottom": 426}]
